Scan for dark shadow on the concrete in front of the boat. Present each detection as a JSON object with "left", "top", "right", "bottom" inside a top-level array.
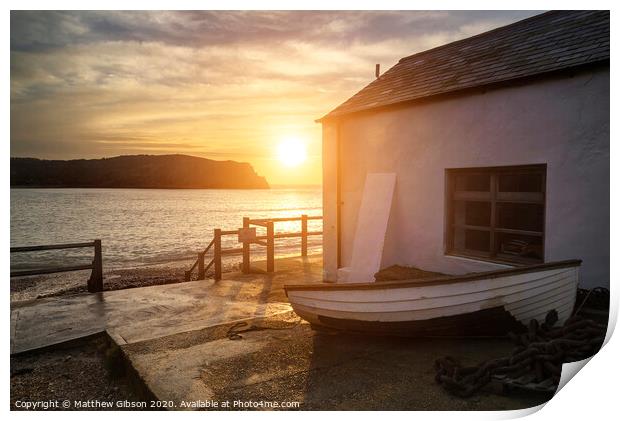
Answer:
[{"left": 301, "top": 332, "right": 549, "bottom": 411}]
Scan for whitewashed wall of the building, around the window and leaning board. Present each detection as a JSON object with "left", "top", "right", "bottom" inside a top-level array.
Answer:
[{"left": 323, "top": 67, "right": 610, "bottom": 287}]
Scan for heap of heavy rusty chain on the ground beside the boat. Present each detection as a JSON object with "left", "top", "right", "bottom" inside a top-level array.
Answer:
[{"left": 435, "top": 310, "right": 607, "bottom": 397}]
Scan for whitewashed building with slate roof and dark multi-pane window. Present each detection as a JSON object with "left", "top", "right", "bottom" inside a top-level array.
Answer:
[{"left": 320, "top": 11, "right": 610, "bottom": 287}]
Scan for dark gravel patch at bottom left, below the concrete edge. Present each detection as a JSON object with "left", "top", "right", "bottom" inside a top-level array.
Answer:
[{"left": 11, "top": 336, "right": 142, "bottom": 410}]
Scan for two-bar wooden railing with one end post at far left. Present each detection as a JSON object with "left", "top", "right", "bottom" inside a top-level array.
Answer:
[{"left": 11, "top": 240, "right": 103, "bottom": 292}]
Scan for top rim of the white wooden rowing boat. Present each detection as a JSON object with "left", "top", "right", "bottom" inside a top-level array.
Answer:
[{"left": 284, "top": 259, "right": 582, "bottom": 290}]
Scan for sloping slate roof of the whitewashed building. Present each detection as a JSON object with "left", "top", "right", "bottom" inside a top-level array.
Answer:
[{"left": 323, "top": 11, "right": 609, "bottom": 118}]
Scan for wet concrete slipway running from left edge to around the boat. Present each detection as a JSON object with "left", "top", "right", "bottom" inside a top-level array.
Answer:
[{"left": 11, "top": 254, "right": 545, "bottom": 410}]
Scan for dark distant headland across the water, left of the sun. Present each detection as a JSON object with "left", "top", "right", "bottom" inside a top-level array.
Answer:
[{"left": 11, "top": 155, "right": 269, "bottom": 189}]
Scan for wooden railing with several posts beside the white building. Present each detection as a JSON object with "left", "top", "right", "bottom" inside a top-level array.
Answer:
[{"left": 185, "top": 215, "right": 323, "bottom": 281}]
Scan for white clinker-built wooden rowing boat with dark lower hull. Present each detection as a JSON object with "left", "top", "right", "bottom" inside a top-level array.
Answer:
[{"left": 284, "top": 260, "right": 581, "bottom": 336}]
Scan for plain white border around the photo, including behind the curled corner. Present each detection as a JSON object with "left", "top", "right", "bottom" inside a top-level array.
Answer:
[{"left": 0, "top": 0, "right": 620, "bottom": 420}]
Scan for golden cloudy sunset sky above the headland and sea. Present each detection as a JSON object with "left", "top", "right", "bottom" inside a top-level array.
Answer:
[{"left": 11, "top": 11, "right": 538, "bottom": 184}]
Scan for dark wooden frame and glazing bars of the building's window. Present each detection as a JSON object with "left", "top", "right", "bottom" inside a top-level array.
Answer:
[{"left": 444, "top": 164, "right": 547, "bottom": 265}]
